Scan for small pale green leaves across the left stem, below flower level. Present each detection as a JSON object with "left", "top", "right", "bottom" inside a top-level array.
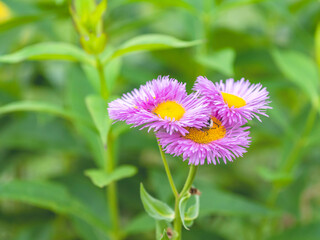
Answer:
[{"left": 85, "top": 165, "right": 137, "bottom": 188}]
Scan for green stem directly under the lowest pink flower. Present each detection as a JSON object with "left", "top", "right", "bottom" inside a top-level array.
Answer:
[{"left": 173, "top": 165, "right": 198, "bottom": 240}]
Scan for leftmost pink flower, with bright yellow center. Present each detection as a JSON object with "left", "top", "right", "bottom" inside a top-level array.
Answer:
[{"left": 108, "top": 76, "right": 209, "bottom": 135}]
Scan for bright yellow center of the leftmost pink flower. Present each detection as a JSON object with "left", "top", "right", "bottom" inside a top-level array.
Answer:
[{"left": 153, "top": 101, "right": 186, "bottom": 120}]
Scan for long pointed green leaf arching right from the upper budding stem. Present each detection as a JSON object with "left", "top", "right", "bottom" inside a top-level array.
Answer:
[{"left": 102, "top": 34, "right": 202, "bottom": 62}]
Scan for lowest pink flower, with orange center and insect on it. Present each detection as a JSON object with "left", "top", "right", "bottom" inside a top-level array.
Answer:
[{"left": 156, "top": 115, "right": 250, "bottom": 165}]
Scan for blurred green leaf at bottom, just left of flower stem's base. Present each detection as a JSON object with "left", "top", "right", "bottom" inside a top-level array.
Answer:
[{"left": 124, "top": 213, "right": 154, "bottom": 235}]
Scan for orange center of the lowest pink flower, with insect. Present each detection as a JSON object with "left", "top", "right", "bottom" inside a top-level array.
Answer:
[{"left": 184, "top": 117, "right": 226, "bottom": 144}]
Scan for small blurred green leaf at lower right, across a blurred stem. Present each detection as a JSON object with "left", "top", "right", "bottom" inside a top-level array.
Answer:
[{"left": 258, "top": 167, "right": 293, "bottom": 187}]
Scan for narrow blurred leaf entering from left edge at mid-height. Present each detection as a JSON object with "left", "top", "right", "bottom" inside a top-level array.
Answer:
[{"left": 0, "top": 101, "right": 92, "bottom": 126}]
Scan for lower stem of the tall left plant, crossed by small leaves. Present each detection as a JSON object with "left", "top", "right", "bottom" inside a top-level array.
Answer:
[{"left": 105, "top": 133, "right": 121, "bottom": 240}]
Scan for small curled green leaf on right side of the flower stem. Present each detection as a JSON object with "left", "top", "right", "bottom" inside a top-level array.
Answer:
[{"left": 179, "top": 193, "right": 200, "bottom": 230}]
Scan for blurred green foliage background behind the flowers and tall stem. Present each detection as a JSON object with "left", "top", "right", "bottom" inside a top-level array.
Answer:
[{"left": 0, "top": 0, "right": 320, "bottom": 240}]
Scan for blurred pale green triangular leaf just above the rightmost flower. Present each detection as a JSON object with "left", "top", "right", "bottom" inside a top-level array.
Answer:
[{"left": 197, "top": 48, "right": 236, "bottom": 76}]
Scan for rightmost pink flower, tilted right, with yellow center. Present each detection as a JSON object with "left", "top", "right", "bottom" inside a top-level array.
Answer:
[{"left": 193, "top": 76, "right": 271, "bottom": 125}]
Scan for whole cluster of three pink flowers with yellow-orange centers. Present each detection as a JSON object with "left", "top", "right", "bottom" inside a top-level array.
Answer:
[{"left": 108, "top": 76, "right": 271, "bottom": 165}]
